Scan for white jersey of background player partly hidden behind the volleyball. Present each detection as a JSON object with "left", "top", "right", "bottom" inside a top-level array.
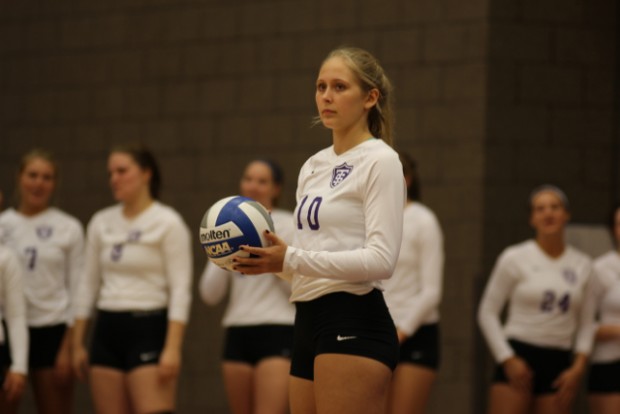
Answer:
[{"left": 199, "top": 209, "right": 295, "bottom": 327}]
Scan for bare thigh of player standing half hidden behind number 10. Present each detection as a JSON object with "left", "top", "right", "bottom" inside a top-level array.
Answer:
[{"left": 388, "top": 364, "right": 437, "bottom": 414}]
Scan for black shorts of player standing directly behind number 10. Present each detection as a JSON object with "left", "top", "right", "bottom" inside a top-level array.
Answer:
[{"left": 398, "top": 323, "right": 440, "bottom": 371}]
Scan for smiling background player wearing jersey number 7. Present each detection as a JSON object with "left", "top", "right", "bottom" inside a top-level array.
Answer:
[{"left": 0, "top": 149, "right": 84, "bottom": 414}]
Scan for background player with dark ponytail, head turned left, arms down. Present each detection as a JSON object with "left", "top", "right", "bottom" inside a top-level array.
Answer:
[{"left": 73, "top": 146, "right": 192, "bottom": 414}]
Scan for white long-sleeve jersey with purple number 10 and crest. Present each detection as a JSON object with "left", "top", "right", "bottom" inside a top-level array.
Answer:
[{"left": 283, "top": 139, "right": 406, "bottom": 301}]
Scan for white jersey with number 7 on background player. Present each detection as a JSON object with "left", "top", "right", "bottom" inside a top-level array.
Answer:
[{"left": 0, "top": 207, "right": 84, "bottom": 327}]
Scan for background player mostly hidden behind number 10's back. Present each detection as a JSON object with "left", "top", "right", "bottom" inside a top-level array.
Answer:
[{"left": 384, "top": 153, "right": 444, "bottom": 414}]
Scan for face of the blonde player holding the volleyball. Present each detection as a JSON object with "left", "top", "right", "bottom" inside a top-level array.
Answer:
[{"left": 315, "top": 57, "right": 378, "bottom": 131}]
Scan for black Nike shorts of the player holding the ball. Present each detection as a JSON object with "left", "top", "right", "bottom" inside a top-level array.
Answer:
[{"left": 291, "top": 289, "right": 398, "bottom": 380}]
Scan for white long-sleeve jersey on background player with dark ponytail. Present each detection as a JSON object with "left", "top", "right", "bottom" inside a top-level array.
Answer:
[{"left": 75, "top": 201, "right": 192, "bottom": 322}]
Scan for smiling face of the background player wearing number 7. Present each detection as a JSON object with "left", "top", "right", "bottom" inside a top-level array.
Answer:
[{"left": 19, "top": 158, "right": 56, "bottom": 210}]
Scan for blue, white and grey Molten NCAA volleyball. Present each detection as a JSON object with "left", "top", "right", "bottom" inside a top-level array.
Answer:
[{"left": 200, "top": 196, "right": 274, "bottom": 270}]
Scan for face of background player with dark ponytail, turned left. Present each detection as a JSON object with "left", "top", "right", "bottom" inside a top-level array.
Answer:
[{"left": 108, "top": 152, "right": 151, "bottom": 202}]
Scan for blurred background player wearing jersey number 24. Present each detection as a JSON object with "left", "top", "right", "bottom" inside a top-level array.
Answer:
[{"left": 478, "top": 186, "right": 593, "bottom": 414}]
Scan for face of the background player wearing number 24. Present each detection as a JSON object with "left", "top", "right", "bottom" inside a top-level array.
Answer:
[{"left": 530, "top": 191, "right": 570, "bottom": 236}]
